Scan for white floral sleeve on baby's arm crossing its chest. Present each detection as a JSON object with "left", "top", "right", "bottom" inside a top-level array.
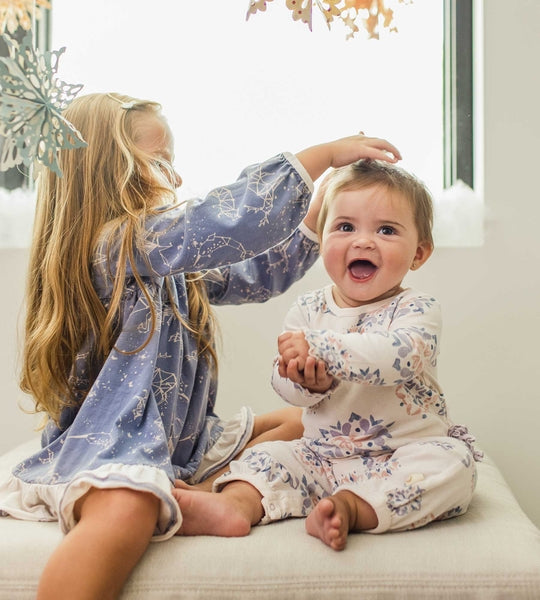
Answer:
[{"left": 305, "top": 296, "right": 441, "bottom": 386}]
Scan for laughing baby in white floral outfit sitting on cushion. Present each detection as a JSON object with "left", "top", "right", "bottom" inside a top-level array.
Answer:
[{"left": 174, "top": 160, "right": 479, "bottom": 550}]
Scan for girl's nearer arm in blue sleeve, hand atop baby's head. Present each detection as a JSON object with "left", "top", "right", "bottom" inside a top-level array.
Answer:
[{"left": 140, "top": 135, "right": 400, "bottom": 275}]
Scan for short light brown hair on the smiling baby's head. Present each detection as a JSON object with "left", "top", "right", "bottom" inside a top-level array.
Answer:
[{"left": 317, "top": 159, "right": 433, "bottom": 248}]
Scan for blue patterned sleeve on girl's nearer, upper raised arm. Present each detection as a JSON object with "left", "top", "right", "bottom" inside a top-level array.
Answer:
[{"left": 95, "top": 153, "right": 313, "bottom": 277}]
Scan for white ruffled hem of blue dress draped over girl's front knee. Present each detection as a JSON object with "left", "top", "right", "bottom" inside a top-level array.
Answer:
[{"left": 0, "top": 464, "right": 182, "bottom": 541}]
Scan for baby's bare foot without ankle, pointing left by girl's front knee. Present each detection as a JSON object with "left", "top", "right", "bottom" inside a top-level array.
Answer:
[{"left": 172, "top": 488, "right": 251, "bottom": 537}]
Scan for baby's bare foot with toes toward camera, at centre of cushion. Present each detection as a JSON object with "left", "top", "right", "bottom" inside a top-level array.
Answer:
[{"left": 306, "top": 490, "right": 378, "bottom": 550}]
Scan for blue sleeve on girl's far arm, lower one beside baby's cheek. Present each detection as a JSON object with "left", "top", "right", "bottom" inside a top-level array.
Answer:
[{"left": 206, "top": 223, "right": 319, "bottom": 304}]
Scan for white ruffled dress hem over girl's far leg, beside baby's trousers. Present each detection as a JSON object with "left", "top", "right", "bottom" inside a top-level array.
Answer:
[{"left": 188, "top": 406, "right": 255, "bottom": 484}]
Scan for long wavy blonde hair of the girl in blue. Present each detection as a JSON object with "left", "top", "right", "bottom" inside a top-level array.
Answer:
[{"left": 20, "top": 94, "right": 217, "bottom": 423}]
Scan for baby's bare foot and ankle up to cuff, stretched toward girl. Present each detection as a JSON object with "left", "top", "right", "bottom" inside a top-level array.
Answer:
[{"left": 172, "top": 481, "right": 264, "bottom": 537}]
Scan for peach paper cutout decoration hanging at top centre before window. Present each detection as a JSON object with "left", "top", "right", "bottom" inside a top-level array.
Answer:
[{"left": 246, "top": 0, "right": 413, "bottom": 39}]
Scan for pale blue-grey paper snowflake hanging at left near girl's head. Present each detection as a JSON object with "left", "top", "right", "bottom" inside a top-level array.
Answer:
[{"left": 0, "top": 33, "right": 87, "bottom": 177}]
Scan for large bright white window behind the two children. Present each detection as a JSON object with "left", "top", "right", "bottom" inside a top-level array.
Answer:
[{"left": 0, "top": 0, "right": 480, "bottom": 246}]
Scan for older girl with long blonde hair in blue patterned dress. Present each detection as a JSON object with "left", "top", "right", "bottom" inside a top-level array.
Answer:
[{"left": 0, "top": 94, "right": 398, "bottom": 600}]
